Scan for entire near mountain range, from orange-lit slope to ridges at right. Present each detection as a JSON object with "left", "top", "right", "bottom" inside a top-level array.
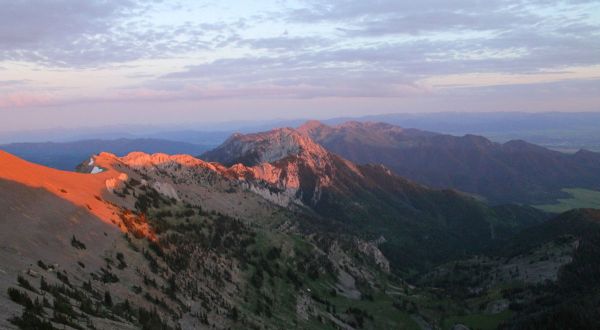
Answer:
[{"left": 0, "top": 122, "right": 600, "bottom": 329}]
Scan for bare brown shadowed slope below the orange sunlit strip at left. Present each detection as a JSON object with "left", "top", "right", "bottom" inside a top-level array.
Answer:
[{"left": 0, "top": 179, "right": 126, "bottom": 329}]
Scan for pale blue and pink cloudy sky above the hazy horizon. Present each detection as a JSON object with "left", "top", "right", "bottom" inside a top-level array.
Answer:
[{"left": 0, "top": 0, "right": 600, "bottom": 131}]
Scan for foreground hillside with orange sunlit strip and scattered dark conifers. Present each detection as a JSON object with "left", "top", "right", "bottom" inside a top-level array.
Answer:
[{"left": 0, "top": 152, "right": 424, "bottom": 329}]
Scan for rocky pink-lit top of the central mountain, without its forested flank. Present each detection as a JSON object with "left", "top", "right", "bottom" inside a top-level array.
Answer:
[{"left": 201, "top": 128, "right": 350, "bottom": 205}]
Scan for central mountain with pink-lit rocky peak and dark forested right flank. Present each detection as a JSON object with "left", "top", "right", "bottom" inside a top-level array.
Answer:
[{"left": 202, "top": 128, "right": 545, "bottom": 271}]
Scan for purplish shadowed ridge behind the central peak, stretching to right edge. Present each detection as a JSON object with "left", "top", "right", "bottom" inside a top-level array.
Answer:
[{"left": 299, "top": 121, "right": 600, "bottom": 204}]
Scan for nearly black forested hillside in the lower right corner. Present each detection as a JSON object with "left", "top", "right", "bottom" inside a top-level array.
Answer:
[{"left": 508, "top": 209, "right": 600, "bottom": 329}]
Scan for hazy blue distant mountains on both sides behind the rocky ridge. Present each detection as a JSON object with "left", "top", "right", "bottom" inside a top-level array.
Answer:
[{"left": 0, "top": 112, "right": 600, "bottom": 151}]
